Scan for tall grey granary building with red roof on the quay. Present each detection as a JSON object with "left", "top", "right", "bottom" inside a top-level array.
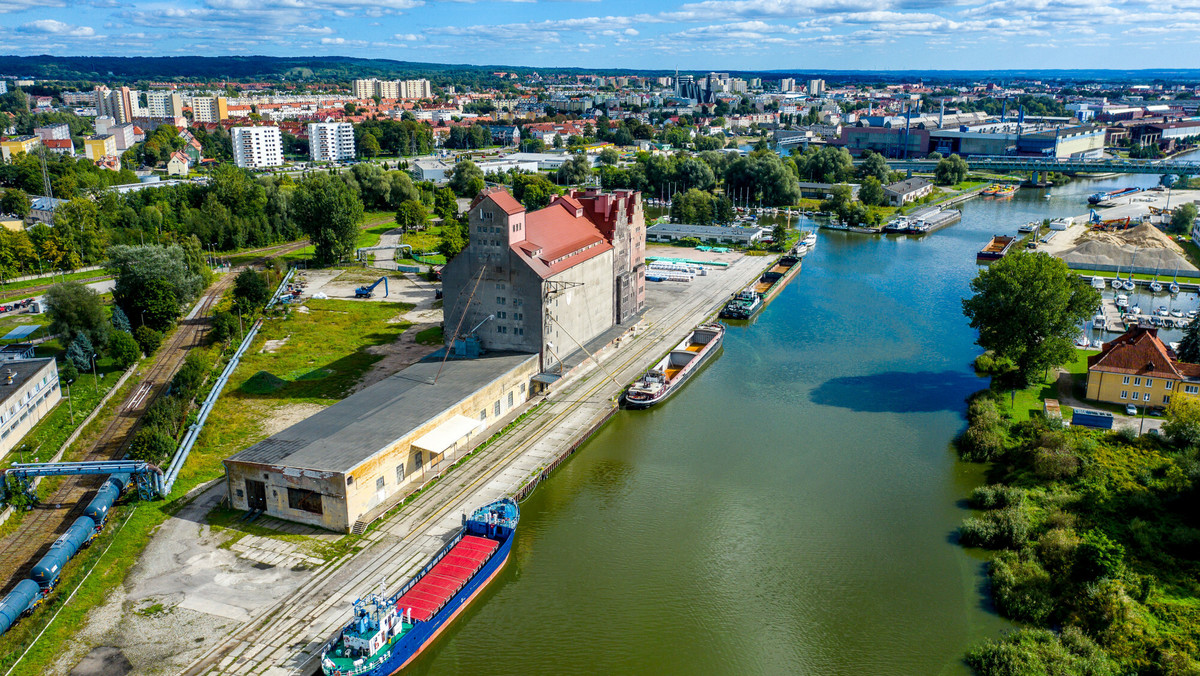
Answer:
[{"left": 442, "top": 187, "right": 646, "bottom": 371}]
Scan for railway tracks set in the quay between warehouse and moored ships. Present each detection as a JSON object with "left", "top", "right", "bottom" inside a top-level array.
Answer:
[{"left": 182, "top": 252, "right": 760, "bottom": 676}]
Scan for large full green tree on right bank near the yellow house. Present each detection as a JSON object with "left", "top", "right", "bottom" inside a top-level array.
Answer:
[{"left": 962, "top": 251, "right": 1100, "bottom": 385}]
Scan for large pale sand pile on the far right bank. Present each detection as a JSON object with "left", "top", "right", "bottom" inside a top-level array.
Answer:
[{"left": 1062, "top": 223, "right": 1196, "bottom": 273}]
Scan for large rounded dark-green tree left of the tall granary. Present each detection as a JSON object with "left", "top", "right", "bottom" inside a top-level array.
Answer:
[{"left": 292, "top": 174, "right": 362, "bottom": 265}]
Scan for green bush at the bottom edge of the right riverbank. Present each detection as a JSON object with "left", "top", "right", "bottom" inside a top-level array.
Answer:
[{"left": 966, "top": 627, "right": 1121, "bottom": 676}]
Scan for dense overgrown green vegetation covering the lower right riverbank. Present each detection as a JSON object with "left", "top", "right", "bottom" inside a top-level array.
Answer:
[{"left": 959, "top": 393, "right": 1200, "bottom": 676}]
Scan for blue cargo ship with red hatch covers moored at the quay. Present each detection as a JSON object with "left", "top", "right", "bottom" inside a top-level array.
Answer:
[{"left": 320, "top": 498, "right": 521, "bottom": 676}]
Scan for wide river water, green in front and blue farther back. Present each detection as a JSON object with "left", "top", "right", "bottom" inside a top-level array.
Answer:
[{"left": 413, "top": 159, "right": 1195, "bottom": 675}]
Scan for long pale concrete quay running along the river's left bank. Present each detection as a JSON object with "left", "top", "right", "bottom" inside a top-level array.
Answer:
[{"left": 184, "top": 249, "right": 774, "bottom": 676}]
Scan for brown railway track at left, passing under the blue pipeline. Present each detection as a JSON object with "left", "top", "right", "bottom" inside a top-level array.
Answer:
[{"left": 0, "top": 275, "right": 234, "bottom": 594}]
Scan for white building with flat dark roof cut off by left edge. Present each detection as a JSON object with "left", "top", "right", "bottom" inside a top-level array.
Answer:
[{"left": 0, "top": 359, "right": 62, "bottom": 457}]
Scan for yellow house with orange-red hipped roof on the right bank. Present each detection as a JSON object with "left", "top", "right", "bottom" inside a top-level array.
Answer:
[{"left": 1087, "top": 327, "right": 1200, "bottom": 406}]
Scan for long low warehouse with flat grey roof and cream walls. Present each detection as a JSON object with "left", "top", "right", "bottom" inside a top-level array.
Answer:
[{"left": 224, "top": 353, "right": 538, "bottom": 532}]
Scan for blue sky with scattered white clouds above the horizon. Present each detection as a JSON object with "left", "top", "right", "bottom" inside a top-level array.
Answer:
[{"left": 0, "top": 0, "right": 1200, "bottom": 71}]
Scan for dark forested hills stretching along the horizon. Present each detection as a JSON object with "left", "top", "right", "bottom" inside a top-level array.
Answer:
[{"left": 0, "top": 55, "right": 1200, "bottom": 83}]
